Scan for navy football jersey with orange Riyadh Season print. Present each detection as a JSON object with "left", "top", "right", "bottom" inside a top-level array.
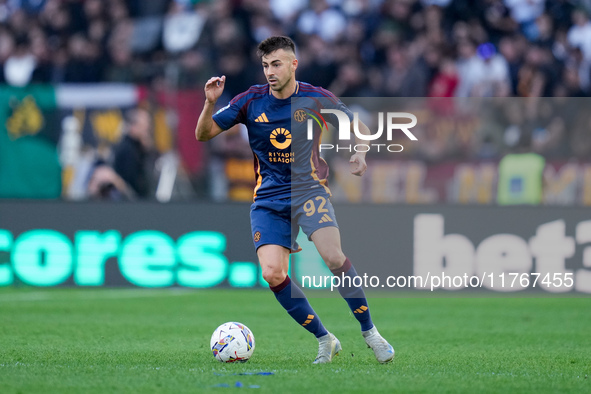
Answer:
[{"left": 213, "top": 82, "right": 353, "bottom": 201}]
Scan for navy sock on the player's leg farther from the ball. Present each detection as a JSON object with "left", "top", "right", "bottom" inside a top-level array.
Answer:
[{"left": 331, "top": 258, "right": 373, "bottom": 331}]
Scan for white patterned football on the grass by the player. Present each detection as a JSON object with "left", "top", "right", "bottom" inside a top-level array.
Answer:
[{"left": 209, "top": 322, "right": 255, "bottom": 363}]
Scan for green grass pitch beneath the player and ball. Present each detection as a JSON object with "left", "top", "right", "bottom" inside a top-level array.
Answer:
[{"left": 0, "top": 288, "right": 591, "bottom": 394}]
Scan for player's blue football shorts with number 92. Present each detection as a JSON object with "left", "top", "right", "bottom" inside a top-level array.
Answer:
[{"left": 250, "top": 195, "right": 338, "bottom": 253}]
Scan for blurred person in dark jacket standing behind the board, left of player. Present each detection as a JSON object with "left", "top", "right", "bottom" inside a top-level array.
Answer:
[{"left": 113, "top": 108, "right": 154, "bottom": 198}]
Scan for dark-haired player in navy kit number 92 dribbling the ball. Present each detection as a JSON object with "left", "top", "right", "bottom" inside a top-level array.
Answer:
[{"left": 195, "top": 36, "right": 394, "bottom": 364}]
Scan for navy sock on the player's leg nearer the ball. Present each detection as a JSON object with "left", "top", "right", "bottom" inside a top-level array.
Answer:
[{"left": 270, "top": 276, "right": 328, "bottom": 338}]
